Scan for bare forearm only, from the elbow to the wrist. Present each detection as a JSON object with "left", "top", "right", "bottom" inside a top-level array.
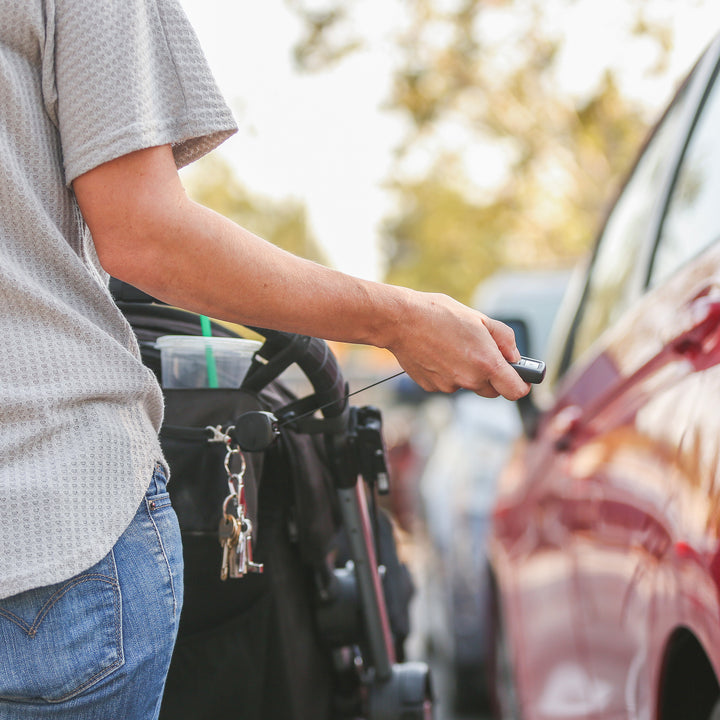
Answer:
[{"left": 110, "top": 199, "right": 413, "bottom": 346}]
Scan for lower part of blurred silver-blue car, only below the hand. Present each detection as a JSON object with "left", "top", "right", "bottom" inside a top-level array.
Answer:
[{"left": 421, "top": 393, "right": 520, "bottom": 712}]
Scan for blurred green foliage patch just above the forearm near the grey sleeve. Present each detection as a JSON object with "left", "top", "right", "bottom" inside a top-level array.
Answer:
[{"left": 183, "top": 153, "right": 327, "bottom": 263}]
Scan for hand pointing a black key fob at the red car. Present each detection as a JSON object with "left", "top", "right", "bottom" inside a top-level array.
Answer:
[{"left": 387, "top": 293, "right": 530, "bottom": 400}]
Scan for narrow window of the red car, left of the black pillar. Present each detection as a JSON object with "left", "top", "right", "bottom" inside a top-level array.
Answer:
[{"left": 569, "top": 85, "right": 687, "bottom": 361}]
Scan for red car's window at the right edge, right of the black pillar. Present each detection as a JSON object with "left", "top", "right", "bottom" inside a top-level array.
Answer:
[{"left": 649, "top": 63, "right": 720, "bottom": 285}]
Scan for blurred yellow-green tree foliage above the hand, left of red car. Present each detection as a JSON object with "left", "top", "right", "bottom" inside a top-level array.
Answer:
[{"left": 291, "top": 0, "right": 672, "bottom": 299}]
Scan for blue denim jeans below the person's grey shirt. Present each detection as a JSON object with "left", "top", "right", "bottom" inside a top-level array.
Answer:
[{"left": 0, "top": 466, "right": 183, "bottom": 720}]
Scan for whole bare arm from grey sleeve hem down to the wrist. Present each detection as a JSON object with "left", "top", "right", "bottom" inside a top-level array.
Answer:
[{"left": 74, "top": 147, "right": 404, "bottom": 346}]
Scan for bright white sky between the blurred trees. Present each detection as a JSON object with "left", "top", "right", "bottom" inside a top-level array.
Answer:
[{"left": 181, "top": 0, "right": 720, "bottom": 278}]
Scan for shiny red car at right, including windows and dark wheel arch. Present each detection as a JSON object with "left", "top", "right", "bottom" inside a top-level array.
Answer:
[{"left": 486, "top": 28, "right": 720, "bottom": 720}]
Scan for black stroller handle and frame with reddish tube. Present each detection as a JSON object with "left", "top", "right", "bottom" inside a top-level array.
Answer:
[{"left": 231, "top": 328, "right": 433, "bottom": 720}]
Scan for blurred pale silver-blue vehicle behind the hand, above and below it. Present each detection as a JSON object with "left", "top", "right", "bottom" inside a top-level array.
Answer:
[{"left": 419, "top": 270, "right": 568, "bottom": 712}]
